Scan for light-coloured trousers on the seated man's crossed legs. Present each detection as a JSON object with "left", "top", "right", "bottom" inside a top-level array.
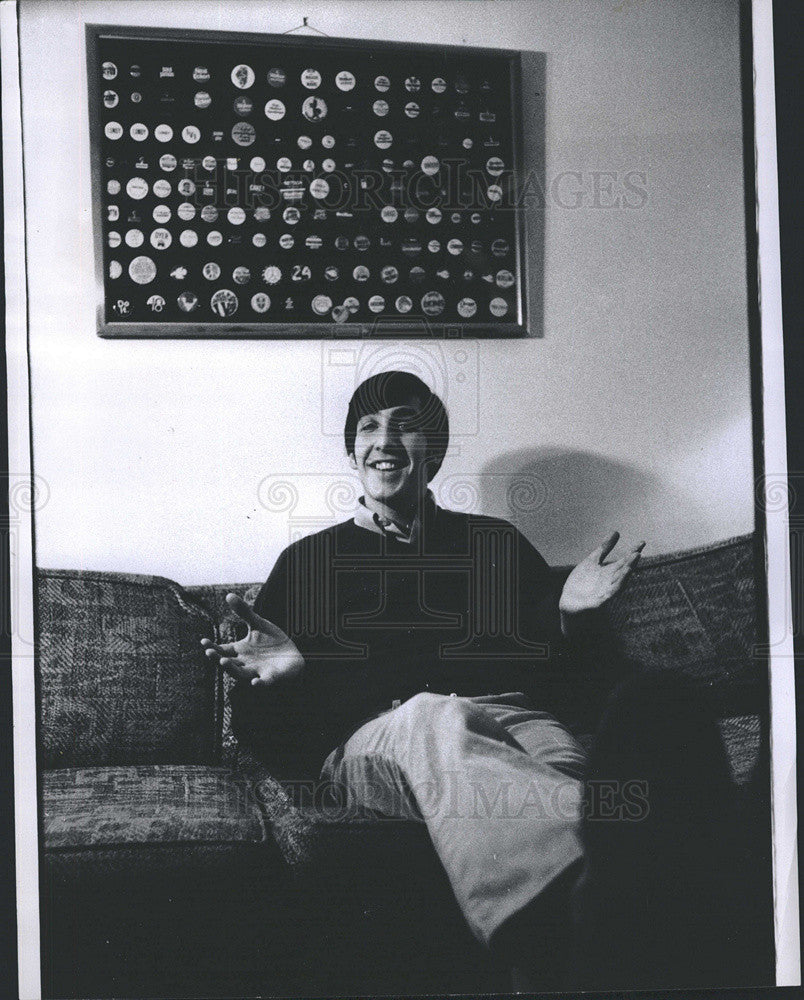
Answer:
[{"left": 322, "top": 692, "right": 585, "bottom": 944}]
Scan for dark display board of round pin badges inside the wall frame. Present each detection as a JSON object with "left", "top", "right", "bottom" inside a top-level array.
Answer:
[{"left": 90, "top": 33, "right": 521, "bottom": 334}]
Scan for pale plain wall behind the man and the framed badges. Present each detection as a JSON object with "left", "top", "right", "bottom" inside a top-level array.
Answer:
[{"left": 21, "top": 0, "right": 753, "bottom": 584}]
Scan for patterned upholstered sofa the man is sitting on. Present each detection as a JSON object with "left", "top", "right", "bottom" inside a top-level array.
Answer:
[{"left": 36, "top": 536, "right": 773, "bottom": 997}]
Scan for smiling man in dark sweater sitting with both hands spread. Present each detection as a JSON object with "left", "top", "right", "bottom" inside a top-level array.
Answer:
[{"left": 204, "top": 371, "right": 642, "bottom": 988}]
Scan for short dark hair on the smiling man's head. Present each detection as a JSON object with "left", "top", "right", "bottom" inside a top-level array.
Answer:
[{"left": 343, "top": 371, "right": 449, "bottom": 483}]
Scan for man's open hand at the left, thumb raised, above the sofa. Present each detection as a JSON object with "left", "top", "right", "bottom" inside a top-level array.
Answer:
[{"left": 201, "top": 594, "right": 304, "bottom": 685}]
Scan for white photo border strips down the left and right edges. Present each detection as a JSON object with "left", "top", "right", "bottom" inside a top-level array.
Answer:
[{"left": 0, "top": 0, "right": 801, "bottom": 1000}]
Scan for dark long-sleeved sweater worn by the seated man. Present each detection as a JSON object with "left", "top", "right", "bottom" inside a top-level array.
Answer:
[{"left": 232, "top": 504, "right": 576, "bottom": 771}]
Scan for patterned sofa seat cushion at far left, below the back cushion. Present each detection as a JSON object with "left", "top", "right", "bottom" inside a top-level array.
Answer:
[{"left": 42, "top": 765, "right": 268, "bottom": 851}]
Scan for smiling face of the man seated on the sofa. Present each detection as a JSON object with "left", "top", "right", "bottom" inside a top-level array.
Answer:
[{"left": 349, "top": 396, "right": 427, "bottom": 512}]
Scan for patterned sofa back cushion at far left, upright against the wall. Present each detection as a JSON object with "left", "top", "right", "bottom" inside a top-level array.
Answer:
[{"left": 37, "top": 570, "right": 222, "bottom": 768}]
